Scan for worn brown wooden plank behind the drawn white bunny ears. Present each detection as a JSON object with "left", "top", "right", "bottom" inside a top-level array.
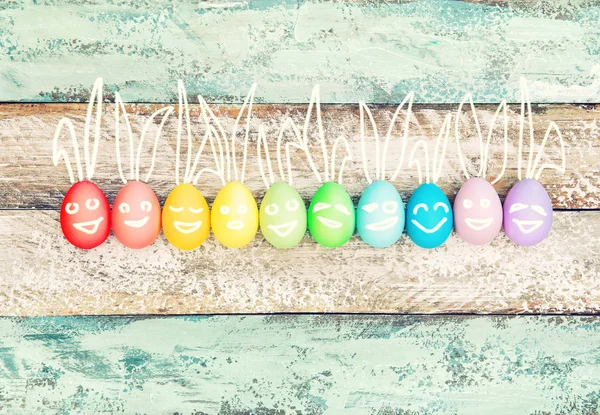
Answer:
[{"left": 0, "top": 102, "right": 600, "bottom": 209}]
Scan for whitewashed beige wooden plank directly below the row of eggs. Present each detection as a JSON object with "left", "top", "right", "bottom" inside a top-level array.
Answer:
[{"left": 0, "top": 211, "right": 600, "bottom": 315}]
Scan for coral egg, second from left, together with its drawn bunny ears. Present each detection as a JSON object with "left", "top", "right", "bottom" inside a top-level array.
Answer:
[{"left": 111, "top": 92, "right": 173, "bottom": 249}]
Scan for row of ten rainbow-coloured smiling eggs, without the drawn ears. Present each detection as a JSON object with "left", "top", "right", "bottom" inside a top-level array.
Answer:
[{"left": 60, "top": 178, "right": 552, "bottom": 250}]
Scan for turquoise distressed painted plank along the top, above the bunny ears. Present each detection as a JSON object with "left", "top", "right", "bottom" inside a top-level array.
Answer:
[{"left": 0, "top": 0, "right": 600, "bottom": 103}]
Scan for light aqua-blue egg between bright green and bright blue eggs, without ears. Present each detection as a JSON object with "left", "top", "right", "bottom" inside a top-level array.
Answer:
[{"left": 356, "top": 180, "right": 404, "bottom": 248}]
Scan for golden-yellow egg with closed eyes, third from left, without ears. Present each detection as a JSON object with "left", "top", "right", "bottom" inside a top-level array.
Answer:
[{"left": 162, "top": 183, "right": 210, "bottom": 250}]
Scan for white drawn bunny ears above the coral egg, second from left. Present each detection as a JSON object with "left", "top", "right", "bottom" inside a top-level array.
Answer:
[{"left": 115, "top": 92, "right": 174, "bottom": 184}]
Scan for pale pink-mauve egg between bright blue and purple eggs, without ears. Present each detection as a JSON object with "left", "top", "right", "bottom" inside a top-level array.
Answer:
[{"left": 454, "top": 177, "right": 502, "bottom": 245}]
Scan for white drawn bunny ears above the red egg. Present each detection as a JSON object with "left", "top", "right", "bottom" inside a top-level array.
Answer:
[{"left": 52, "top": 78, "right": 103, "bottom": 183}]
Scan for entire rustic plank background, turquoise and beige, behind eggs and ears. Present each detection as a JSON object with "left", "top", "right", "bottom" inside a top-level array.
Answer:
[{"left": 0, "top": 0, "right": 600, "bottom": 415}]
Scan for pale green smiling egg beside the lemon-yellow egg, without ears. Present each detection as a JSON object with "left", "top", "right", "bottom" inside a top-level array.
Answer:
[{"left": 260, "top": 182, "right": 306, "bottom": 249}]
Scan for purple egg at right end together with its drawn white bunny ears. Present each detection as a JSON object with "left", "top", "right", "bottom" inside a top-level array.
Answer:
[{"left": 504, "top": 78, "right": 567, "bottom": 246}]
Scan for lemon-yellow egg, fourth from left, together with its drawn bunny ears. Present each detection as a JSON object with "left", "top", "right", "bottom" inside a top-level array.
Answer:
[{"left": 203, "top": 84, "right": 258, "bottom": 248}]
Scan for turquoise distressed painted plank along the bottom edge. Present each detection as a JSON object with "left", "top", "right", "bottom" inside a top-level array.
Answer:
[{"left": 0, "top": 315, "right": 600, "bottom": 415}]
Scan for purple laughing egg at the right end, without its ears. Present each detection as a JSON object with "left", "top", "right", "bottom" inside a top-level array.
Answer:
[{"left": 504, "top": 179, "right": 552, "bottom": 246}]
